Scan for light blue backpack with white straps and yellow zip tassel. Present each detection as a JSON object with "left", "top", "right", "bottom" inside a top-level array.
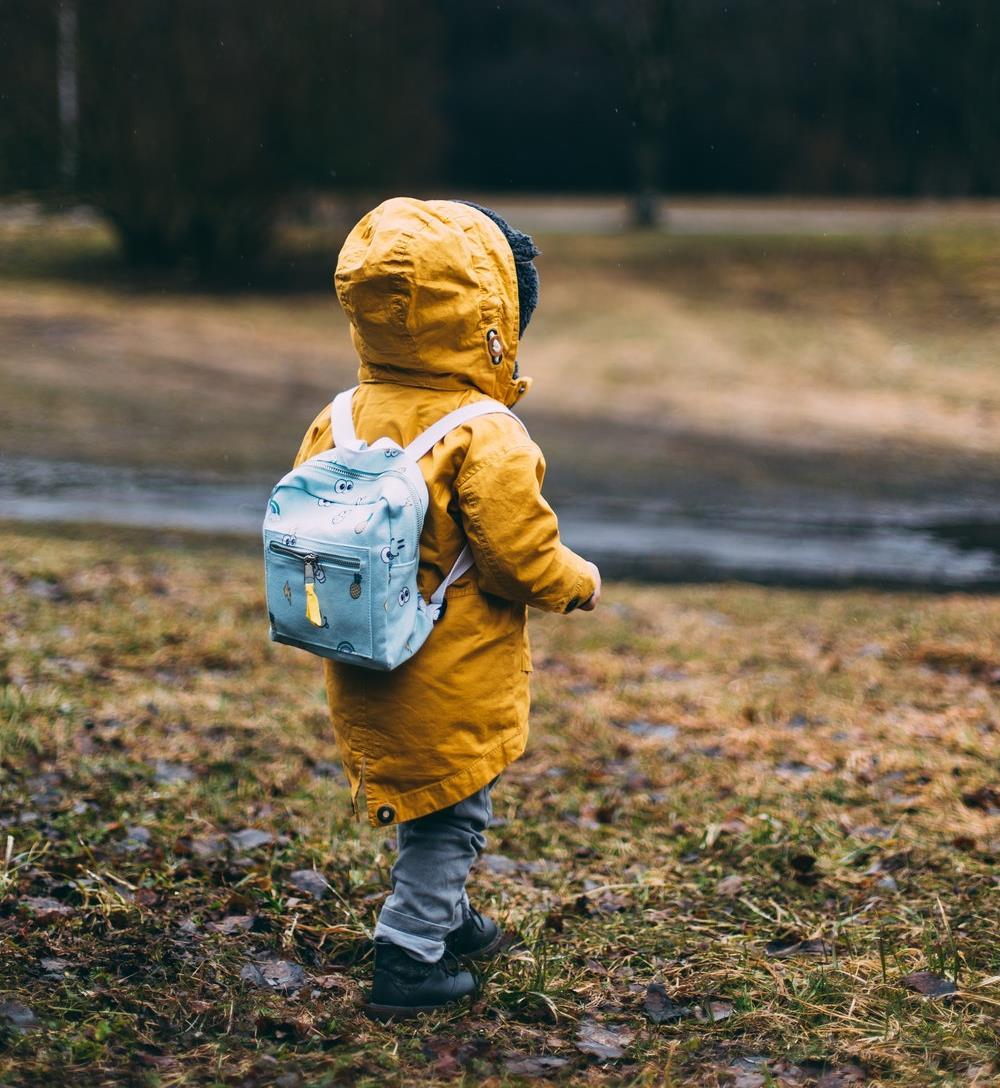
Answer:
[{"left": 263, "top": 386, "right": 520, "bottom": 670}]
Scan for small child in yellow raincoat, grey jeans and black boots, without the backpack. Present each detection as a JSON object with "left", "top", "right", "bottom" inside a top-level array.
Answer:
[{"left": 296, "top": 197, "right": 601, "bottom": 1018}]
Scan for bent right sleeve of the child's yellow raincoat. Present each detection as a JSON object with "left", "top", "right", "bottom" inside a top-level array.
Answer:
[{"left": 456, "top": 441, "right": 596, "bottom": 613}]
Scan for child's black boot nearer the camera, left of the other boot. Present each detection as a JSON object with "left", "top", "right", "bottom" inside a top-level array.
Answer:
[{"left": 365, "top": 941, "right": 476, "bottom": 1019}]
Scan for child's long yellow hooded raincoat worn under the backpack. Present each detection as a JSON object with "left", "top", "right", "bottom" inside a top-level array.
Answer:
[{"left": 295, "top": 197, "right": 595, "bottom": 826}]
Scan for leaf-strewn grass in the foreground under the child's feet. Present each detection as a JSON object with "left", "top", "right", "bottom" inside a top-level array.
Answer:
[{"left": 0, "top": 527, "right": 1000, "bottom": 1088}]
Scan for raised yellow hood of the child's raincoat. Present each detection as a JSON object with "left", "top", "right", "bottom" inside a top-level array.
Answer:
[{"left": 334, "top": 197, "right": 531, "bottom": 406}]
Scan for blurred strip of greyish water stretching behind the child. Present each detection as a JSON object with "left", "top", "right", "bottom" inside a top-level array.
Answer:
[{"left": 0, "top": 459, "right": 1000, "bottom": 592}]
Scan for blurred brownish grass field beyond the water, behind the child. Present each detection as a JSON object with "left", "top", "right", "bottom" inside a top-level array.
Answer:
[{"left": 0, "top": 204, "right": 1000, "bottom": 479}]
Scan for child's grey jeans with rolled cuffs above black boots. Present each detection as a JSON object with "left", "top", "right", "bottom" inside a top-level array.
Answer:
[{"left": 375, "top": 778, "right": 496, "bottom": 963}]
